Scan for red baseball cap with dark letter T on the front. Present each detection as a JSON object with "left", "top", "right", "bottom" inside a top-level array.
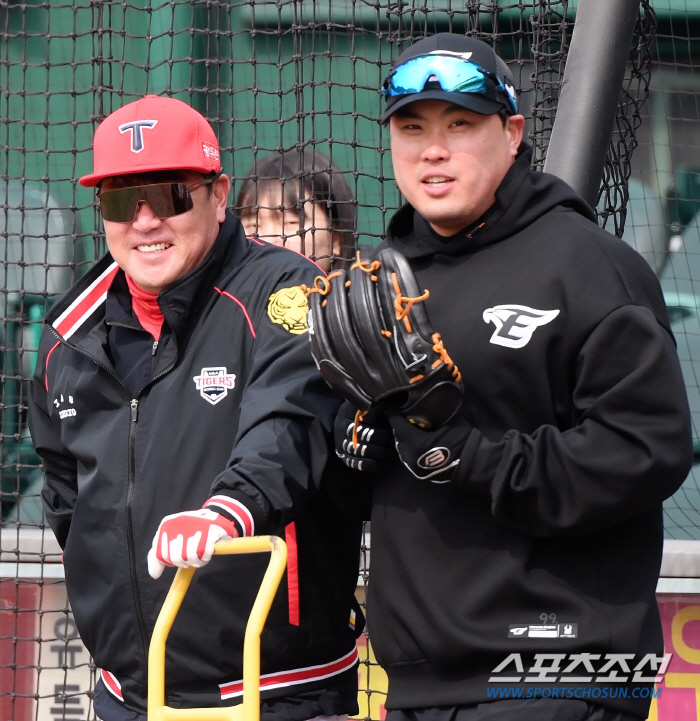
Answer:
[{"left": 79, "top": 95, "right": 221, "bottom": 188}]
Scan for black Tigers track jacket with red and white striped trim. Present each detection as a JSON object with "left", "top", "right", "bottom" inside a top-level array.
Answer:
[{"left": 30, "top": 213, "right": 363, "bottom": 718}]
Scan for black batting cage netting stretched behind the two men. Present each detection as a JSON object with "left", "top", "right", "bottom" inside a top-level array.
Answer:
[{"left": 0, "top": 0, "right": 700, "bottom": 721}]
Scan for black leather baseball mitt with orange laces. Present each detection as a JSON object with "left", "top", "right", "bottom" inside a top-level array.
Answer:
[{"left": 304, "top": 248, "right": 463, "bottom": 429}]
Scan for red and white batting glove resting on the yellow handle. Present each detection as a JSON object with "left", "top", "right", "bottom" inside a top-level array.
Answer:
[{"left": 148, "top": 508, "right": 238, "bottom": 578}]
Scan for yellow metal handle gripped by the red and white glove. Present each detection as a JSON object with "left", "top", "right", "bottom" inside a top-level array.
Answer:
[{"left": 148, "top": 536, "right": 287, "bottom": 721}]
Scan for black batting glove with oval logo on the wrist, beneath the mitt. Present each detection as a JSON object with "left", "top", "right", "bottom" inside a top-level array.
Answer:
[{"left": 388, "top": 411, "right": 473, "bottom": 483}]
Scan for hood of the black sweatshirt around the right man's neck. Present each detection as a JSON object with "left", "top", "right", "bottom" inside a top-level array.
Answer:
[{"left": 387, "top": 143, "right": 596, "bottom": 258}]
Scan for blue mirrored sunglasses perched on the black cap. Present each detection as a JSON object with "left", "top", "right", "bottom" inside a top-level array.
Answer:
[{"left": 382, "top": 55, "right": 518, "bottom": 113}]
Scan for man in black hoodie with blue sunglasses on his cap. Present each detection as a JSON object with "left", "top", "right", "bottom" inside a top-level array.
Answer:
[{"left": 336, "top": 33, "right": 692, "bottom": 721}]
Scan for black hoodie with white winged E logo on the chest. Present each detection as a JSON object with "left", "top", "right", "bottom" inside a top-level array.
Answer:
[{"left": 369, "top": 146, "right": 692, "bottom": 718}]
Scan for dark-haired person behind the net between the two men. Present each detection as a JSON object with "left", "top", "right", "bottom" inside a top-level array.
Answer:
[{"left": 235, "top": 148, "right": 356, "bottom": 272}]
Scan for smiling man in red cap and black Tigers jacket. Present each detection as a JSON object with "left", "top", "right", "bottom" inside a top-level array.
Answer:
[{"left": 29, "top": 95, "right": 364, "bottom": 721}]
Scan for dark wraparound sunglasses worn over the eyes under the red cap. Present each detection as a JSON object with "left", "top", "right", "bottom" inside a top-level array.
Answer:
[{"left": 97, "top": 173, "right": 221, "bottom": 223}]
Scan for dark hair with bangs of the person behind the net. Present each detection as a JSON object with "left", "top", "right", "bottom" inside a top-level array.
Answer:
[{"left": 234, "top": 148, "right": 357, "bottom": 267}]
